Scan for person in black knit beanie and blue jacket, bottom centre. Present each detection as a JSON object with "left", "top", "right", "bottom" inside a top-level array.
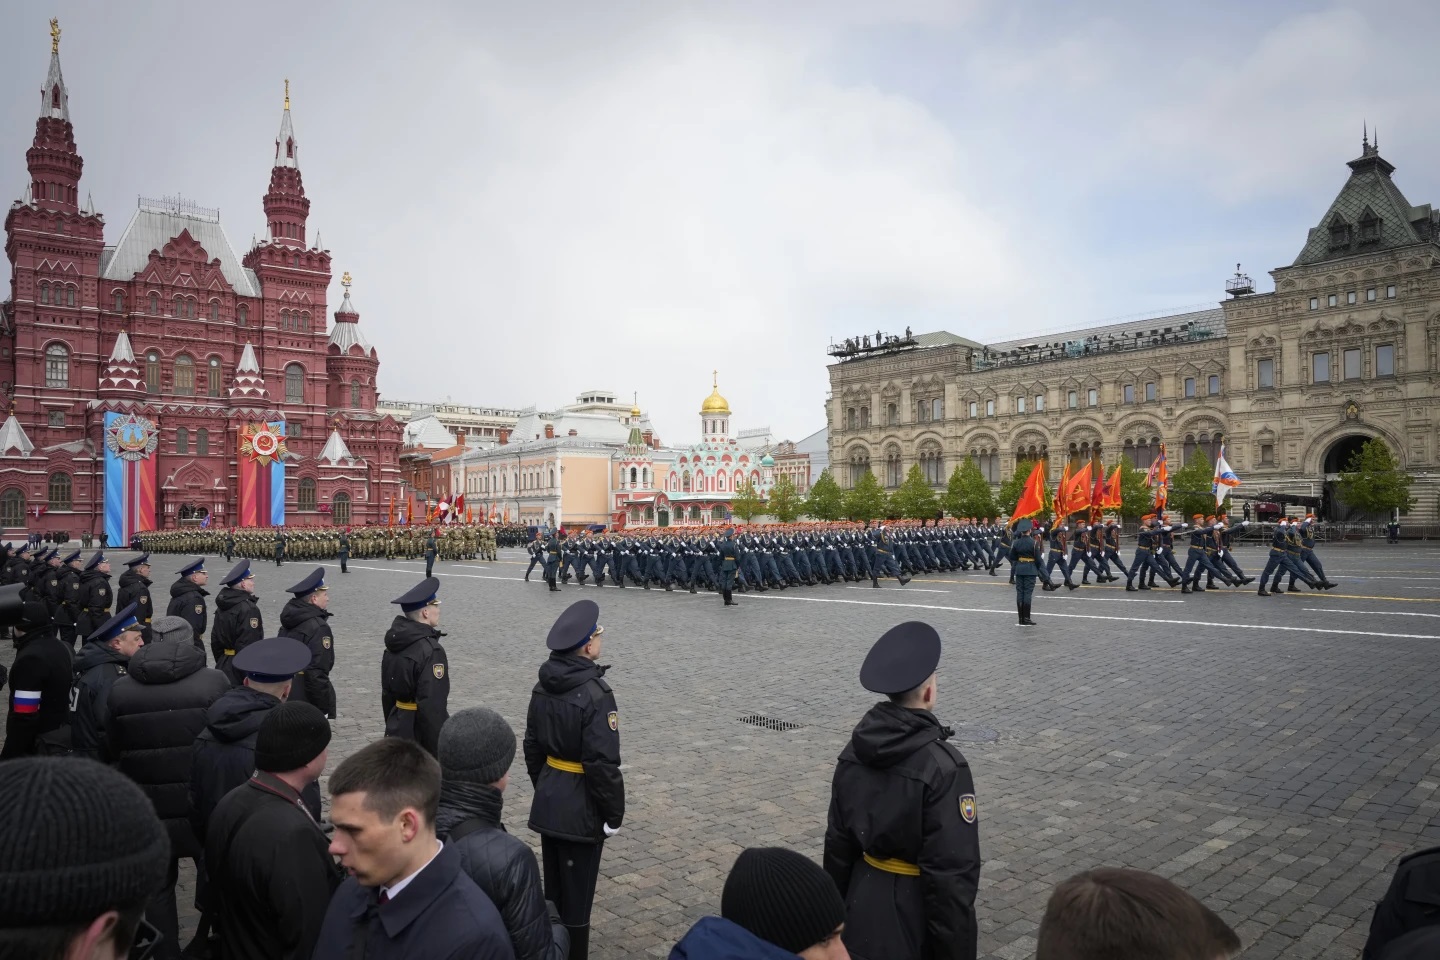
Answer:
[{"left": 670, "top": 846, "right": 850, "bottom": 960}]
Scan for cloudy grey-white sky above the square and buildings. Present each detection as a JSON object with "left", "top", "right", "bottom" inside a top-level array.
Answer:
[{"left": 0, "top": 0, "right": 1440, "bottom": 442}]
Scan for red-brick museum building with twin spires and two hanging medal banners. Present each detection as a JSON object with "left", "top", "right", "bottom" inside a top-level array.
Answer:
[{"left": 0, "top": 22, "right": 403, "bottom": 543}]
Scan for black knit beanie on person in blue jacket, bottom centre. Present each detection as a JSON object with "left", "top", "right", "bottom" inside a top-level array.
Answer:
[{"left": 720, "top": 846, "right": 845, "bottom": 953}]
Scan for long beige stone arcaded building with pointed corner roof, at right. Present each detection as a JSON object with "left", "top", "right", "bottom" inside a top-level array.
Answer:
[{"left": 828, "top": 140, "right": 1440, "bottom": 521}]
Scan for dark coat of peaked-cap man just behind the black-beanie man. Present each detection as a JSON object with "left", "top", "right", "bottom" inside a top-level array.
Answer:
[{"left": 190, "top": 687, "right": 320, "bottom": 845}]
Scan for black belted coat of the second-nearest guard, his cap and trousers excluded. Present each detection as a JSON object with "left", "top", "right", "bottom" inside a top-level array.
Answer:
[{"left": 524, "top": 653, "right": 625, "bottom": 843}]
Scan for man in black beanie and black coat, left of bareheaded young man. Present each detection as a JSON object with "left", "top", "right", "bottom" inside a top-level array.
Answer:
[{"left": 206, "top": 702, "right": 341, "bottom": 960}]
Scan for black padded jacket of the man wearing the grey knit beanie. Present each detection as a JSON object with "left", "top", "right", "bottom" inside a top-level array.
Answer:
[{"left": 435, "top": 782, "right": 566, "bottom": 960}]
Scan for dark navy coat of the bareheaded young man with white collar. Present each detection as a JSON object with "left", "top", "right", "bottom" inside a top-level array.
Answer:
[{"left": 315, "top": 845, "right": 516, "bottom": 960}]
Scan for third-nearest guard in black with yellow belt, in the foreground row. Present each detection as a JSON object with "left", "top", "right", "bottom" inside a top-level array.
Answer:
[{"left": 380, "top": 577, "right": 449, "bottom": 756}]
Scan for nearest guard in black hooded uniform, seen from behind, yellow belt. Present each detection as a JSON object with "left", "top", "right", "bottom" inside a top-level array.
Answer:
[{"left": 825, "top": 622, "right": 981, "bottom": 960}]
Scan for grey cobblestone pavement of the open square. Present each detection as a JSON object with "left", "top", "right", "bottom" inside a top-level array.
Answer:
[{"left": 0, "top": 543, "right": 1440, "bottom": 960}]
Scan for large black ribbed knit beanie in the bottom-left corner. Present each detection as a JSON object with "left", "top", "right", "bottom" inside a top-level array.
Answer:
[{"left": 0, "top": 757, "right": 170, "bottom": 930}]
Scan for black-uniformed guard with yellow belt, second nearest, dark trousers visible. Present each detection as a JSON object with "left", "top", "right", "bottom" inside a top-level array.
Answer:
[{"left": 524, "top": 600, "right": 625, "bottom": 960}]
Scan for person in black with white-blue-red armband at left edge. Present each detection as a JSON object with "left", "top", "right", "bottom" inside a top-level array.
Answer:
[{"left": 0, "top": 596, "right": 75, "bottom": 760}]
